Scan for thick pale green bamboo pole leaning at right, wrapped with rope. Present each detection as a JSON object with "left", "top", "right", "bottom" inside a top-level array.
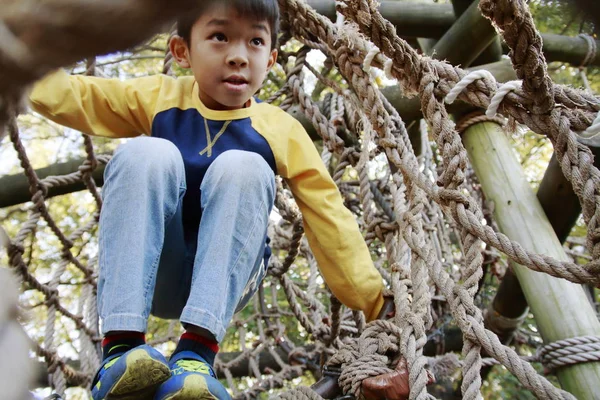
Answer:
[{"left": 463, "top": 122, "right": 600, "bottom": 399}]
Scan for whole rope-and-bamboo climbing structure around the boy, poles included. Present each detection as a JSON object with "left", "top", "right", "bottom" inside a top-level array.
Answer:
[{"left": 0, "top": 0, "right": 600, "bottom": 399}]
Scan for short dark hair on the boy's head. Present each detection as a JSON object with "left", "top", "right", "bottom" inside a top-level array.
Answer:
[{"left": 177, "top": 0, "right": 279, "bottom": 49}]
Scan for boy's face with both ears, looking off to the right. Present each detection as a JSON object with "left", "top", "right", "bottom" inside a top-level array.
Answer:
[{"left": 170, "top": 4, "right": 277, "bottom": 110}]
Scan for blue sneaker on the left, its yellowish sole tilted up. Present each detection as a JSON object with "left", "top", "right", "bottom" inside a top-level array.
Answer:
[{"left": 92, "top": 345, "right": 171, "bottom": 400}]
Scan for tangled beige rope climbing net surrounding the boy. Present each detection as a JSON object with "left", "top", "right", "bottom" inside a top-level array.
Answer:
[{"left": 0, "top": 0, "right": 600, "bottom": 399}]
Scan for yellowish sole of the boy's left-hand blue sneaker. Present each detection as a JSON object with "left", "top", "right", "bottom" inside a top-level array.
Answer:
[{"left": 106, "top": 349, "right": 171, "bottom": 400}]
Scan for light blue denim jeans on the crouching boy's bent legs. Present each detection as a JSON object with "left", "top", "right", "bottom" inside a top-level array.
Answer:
[{"left": 98, "top": 137, "right": 275, "bottom": 341}]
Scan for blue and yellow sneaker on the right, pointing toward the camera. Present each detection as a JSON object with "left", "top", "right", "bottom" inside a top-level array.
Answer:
[{"left": 154, "top": 351, "right": 231, "bottom": 400}]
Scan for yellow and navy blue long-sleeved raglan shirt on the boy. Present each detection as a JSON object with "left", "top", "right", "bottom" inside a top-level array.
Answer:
[{"left": 30, "top": 70, "right": 383, "bottom": 320}]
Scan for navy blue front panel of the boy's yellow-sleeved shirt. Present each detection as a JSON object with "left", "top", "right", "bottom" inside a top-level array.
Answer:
[{"left": 152, "top": 108, "right": 277, "bottom": 233}]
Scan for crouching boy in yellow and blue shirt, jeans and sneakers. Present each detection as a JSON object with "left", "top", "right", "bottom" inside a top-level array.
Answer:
[{"left": 30, "top": 0, "right": 383, "bottom": 400}]
